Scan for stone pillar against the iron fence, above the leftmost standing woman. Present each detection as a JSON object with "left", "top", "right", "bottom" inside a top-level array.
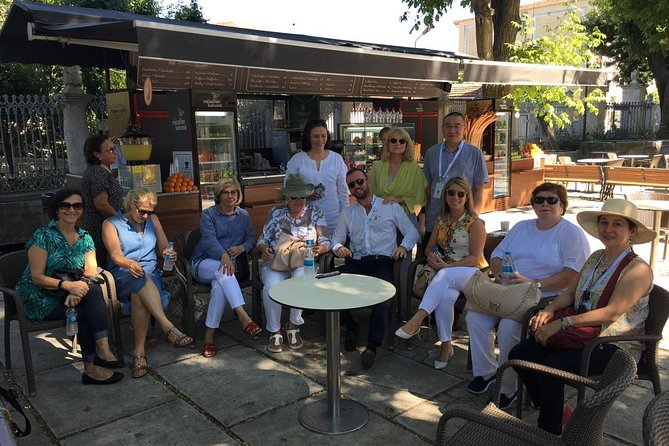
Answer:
[{"left": 61, "top": 67, "right": 91, "bottom": 175}]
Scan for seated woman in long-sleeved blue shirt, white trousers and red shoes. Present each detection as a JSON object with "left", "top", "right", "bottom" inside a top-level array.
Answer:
[{"left": 191, "top": 177, "right": 262, "bottom": 358}]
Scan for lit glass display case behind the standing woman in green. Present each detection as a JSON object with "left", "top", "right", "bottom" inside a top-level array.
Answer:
[{"left": 339, "top": 122, "right": 416, "bottom": 168}]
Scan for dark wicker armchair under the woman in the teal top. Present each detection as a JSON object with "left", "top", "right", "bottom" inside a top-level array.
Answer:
[{"left": 0, "top": 250, "right": 123, "bottom": 396}]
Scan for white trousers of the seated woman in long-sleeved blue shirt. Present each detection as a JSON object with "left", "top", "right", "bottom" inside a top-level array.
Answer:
[{"left": 197, "top": 259, "right": 246, "bottom": 328}]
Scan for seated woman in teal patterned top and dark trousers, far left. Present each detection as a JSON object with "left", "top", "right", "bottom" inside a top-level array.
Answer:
[{"left": 16, "top": 189, "right": 124, "bottom": 384}]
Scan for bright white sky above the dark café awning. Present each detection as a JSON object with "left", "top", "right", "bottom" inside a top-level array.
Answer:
[{"left": 183, "top": 0, "right": 473, "bottom": 51}]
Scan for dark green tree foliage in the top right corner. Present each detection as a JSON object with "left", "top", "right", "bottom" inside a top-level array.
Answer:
[{"left": 587, "top": 0, "right": 669, "bottom": 137}]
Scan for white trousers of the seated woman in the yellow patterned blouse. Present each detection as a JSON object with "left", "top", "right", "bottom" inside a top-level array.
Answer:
[{"left": 418, "top": 266, "right": 478, "bottom": 342}]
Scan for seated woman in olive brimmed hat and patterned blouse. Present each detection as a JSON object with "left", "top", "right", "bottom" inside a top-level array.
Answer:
[{"left": 257, "top": 175, "right": 330, "bottom": 353}]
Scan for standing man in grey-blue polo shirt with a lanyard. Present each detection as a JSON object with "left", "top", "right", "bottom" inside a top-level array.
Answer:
[{"left": 421, "top": 112, "right": 490, "bottom": 246}]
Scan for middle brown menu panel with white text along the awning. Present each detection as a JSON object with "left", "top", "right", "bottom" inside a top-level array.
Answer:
[{"left": 242, "top": 68, "right": 355, "bottom": 96}]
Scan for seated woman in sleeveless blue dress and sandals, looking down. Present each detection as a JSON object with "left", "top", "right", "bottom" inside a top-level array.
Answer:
[{"left": 102, "top": 188, "right": 193, "bottom": 378}]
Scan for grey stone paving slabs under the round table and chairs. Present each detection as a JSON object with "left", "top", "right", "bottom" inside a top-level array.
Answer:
[{"left": 2, "top": 186, "right": 669, "bottom": 446}]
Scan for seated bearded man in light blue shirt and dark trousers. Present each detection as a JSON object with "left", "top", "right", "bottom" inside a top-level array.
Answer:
[{"left": 332, "top": 167, "right": 420, "bottom": 369}]
